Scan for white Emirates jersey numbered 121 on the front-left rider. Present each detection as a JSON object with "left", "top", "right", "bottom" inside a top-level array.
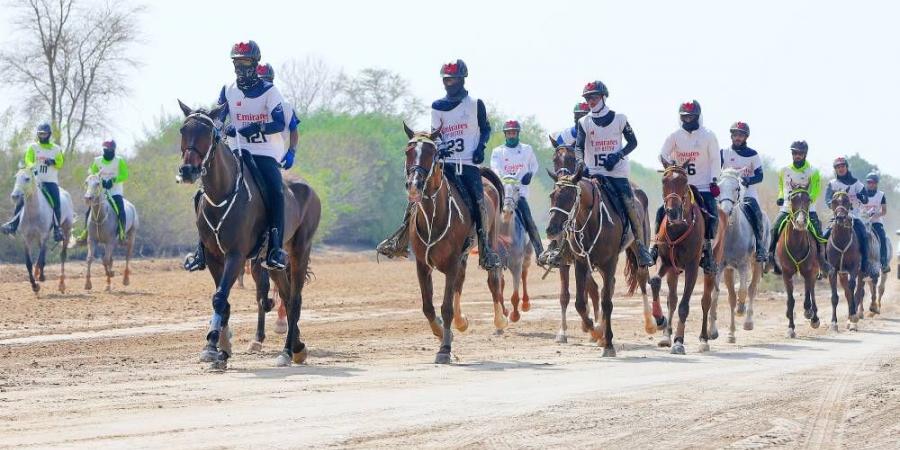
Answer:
[{"left": 225, "top": 84, "right": 287, "bottom": 161}]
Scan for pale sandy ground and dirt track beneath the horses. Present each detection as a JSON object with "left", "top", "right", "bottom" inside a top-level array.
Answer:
[{"left": 0, "top": 251, "right": 900, "bottom": 449}]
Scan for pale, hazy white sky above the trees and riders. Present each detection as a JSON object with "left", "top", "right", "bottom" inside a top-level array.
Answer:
[{"left": 0, "top": 0, "right": 900, "bottom": 176}]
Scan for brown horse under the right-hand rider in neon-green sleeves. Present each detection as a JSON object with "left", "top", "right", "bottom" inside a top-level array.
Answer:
[{"left": 775, "top": 183, "right": 819, "bottom": 339}]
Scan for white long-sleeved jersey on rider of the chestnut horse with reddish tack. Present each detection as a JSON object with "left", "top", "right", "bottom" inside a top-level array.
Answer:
[{"left": 659, "top": 126, "right": 722, "bottom": 192}]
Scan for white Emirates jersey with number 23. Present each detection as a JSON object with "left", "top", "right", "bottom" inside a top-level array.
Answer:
[{"left": 431, "top": 95, "right": 481, "bottom": 166}]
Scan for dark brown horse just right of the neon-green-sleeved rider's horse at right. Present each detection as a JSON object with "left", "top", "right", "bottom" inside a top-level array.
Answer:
[{"left": 825, "top": 191, "right": 863, "bottom": 331}]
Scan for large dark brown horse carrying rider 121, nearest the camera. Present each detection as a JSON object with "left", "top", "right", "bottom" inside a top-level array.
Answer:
[{"left": 176, "top": 100, "right": 322, "bottom": 369}]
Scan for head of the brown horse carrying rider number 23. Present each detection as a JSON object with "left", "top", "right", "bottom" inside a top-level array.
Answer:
[{"left": 403, "top": 122, "right": 441, "bottom": 203}]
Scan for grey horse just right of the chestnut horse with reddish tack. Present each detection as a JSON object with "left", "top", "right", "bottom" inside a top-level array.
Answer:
[{"left": 712, "top": 169, "right": 770, "bottom": 343}]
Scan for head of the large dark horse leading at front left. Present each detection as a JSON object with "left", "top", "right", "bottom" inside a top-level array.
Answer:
[{"left": 176, "top": 100, "right": 225, "bottom": 183}]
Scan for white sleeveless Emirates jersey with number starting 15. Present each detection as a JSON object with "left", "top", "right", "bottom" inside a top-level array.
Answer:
[{"left": 578, "top": 114, "right": 631, "bottom": 178}]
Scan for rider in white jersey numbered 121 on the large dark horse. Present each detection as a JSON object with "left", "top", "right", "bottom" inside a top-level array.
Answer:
[{"left": 184, "top": 41, "right": 294, "bottom": 272}]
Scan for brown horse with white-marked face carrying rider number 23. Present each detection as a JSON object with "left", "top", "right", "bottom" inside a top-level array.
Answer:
[{"left": 403, "top": 123, "right": 509, "bottom": 364}]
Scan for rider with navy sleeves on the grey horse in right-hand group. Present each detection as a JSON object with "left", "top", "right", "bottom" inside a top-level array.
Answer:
[{"left": 722, "top": 122, "right": 768, "bottom": 262}]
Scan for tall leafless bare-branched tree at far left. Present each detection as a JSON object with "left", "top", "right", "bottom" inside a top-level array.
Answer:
[{"left": 0, "top": 0, "right": 143, "bottom": 154}]
